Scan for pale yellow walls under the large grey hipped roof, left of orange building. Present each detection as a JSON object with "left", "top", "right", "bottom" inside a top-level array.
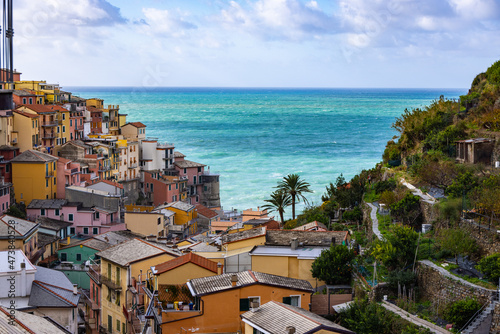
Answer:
[{"left": 101, "top": 253, "right": 174, "bottom": 334}]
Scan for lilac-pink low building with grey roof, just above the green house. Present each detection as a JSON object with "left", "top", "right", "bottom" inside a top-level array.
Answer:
[{"left": 26, "top": 199, "right": 126, "bottom": 236}]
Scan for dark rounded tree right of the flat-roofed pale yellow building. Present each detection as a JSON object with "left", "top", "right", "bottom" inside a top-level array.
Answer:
[{"left": 311, "top": 244, "right": 354, "bottom": 284}]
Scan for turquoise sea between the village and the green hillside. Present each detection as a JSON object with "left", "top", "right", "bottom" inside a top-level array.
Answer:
[{"left": 66, "top": 87, "right": 467, "bottom": 216}]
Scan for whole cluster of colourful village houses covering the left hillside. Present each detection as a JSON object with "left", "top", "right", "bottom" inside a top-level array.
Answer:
[{"left": 0, "top": 70, "right": 351, "bottom": 334}]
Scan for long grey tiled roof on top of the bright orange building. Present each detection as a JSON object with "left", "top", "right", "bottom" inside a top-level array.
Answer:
[{"left": 188, "top": 270, "right": 313, "bottom": 296}]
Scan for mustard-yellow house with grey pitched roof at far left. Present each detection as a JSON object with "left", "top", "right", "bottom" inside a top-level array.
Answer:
[{"left": 11, "top": 150, "right": 58, "bottom": 205}]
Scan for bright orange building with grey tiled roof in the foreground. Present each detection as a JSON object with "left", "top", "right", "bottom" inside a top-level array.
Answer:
[{"left": 154, "top": 271, "right": 313, "bottom": 334}]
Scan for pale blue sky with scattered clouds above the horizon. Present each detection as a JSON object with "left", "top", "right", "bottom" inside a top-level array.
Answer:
[{"left": 8, "top": 0, "right": 500, "bottom": 88}]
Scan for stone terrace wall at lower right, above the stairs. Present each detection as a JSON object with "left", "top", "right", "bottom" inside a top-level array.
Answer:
[{"left": 417, "top": 263, "right": 496, "bottom": 311}]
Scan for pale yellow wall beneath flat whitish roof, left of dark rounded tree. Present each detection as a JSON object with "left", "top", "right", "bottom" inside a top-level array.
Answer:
[{"left": 252, "top": 255, "right": 325, "bottom": 287}]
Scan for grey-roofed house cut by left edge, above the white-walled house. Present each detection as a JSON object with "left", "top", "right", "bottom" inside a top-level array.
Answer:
[{"left": 0, "top": 215, "right": 41, "bottom": 264}]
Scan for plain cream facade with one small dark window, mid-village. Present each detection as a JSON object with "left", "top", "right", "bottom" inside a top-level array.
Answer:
[{"left": 125, "top": 212, "right": 166, "bottom": 236}]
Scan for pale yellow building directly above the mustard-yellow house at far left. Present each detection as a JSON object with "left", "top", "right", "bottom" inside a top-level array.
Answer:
[{"left": 12, "top": 110, "right": 41, "bottom": 152}]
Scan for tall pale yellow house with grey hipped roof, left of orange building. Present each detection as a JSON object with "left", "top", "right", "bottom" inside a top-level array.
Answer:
[{"left": 96, "top": 239, "right": 180, "bottom": 334}]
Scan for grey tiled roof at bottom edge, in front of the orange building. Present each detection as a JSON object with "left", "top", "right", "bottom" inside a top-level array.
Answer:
[{"left": 241, "top": 301, "right": 354, "bottom": 334}]
